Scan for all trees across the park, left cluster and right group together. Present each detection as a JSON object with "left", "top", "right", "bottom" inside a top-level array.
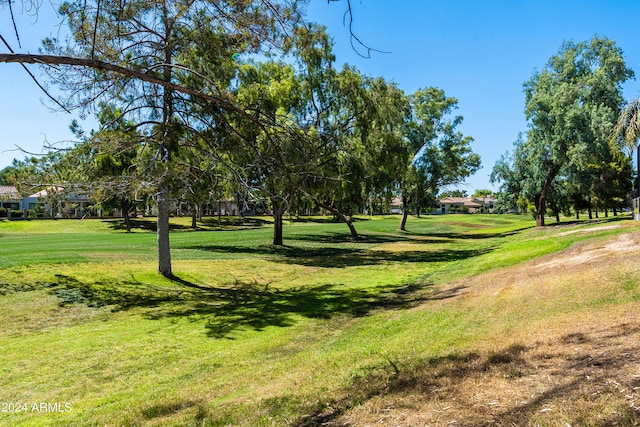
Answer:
[{"left": 6, "top": 5, "right": 638, "bottom": 277}]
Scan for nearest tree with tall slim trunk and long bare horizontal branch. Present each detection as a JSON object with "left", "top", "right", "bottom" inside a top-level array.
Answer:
[{"left": 18, "top": 0, "right": 298, "bottom": 277}]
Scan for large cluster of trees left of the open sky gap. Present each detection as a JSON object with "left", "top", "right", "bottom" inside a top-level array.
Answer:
[{"left": 0, "top": 0, "right": 480, "bottom": 277}]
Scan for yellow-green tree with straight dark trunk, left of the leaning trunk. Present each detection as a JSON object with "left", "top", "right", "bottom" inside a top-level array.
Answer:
[{"left": 227, "top": 62, "right": 314, "bottom": 245}]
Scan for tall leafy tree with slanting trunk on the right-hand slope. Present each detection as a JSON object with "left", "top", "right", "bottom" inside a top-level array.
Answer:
[{"left": 521, "top": 37, "right": 633, "bottom": 226}]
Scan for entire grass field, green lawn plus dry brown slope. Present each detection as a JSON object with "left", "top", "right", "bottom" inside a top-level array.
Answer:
[{"left": 0, "top": 215, "right": 640, "bottom": 426}]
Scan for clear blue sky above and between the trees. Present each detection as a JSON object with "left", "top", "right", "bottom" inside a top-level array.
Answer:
[{"left": 0, "top": 0, "right": 640, "bottom": 192}]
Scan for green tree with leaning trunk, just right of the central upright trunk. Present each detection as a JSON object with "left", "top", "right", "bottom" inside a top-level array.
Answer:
[{"left": 311, "top": 72, "right": 410, "bottom": 238}]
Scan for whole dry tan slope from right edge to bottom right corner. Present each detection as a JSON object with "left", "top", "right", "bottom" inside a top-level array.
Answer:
[{"left": 332, "top": 232, "right": 640, "bottom": 427}]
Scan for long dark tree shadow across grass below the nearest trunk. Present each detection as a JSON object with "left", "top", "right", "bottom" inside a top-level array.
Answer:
[{"left": 49, "top": 275, "right": 458, "bottom": 338}]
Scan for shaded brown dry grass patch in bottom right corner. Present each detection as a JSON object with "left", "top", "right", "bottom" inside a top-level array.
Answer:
[{"left": 334, "top": 319, "right": 640, "bottom": 426}]
